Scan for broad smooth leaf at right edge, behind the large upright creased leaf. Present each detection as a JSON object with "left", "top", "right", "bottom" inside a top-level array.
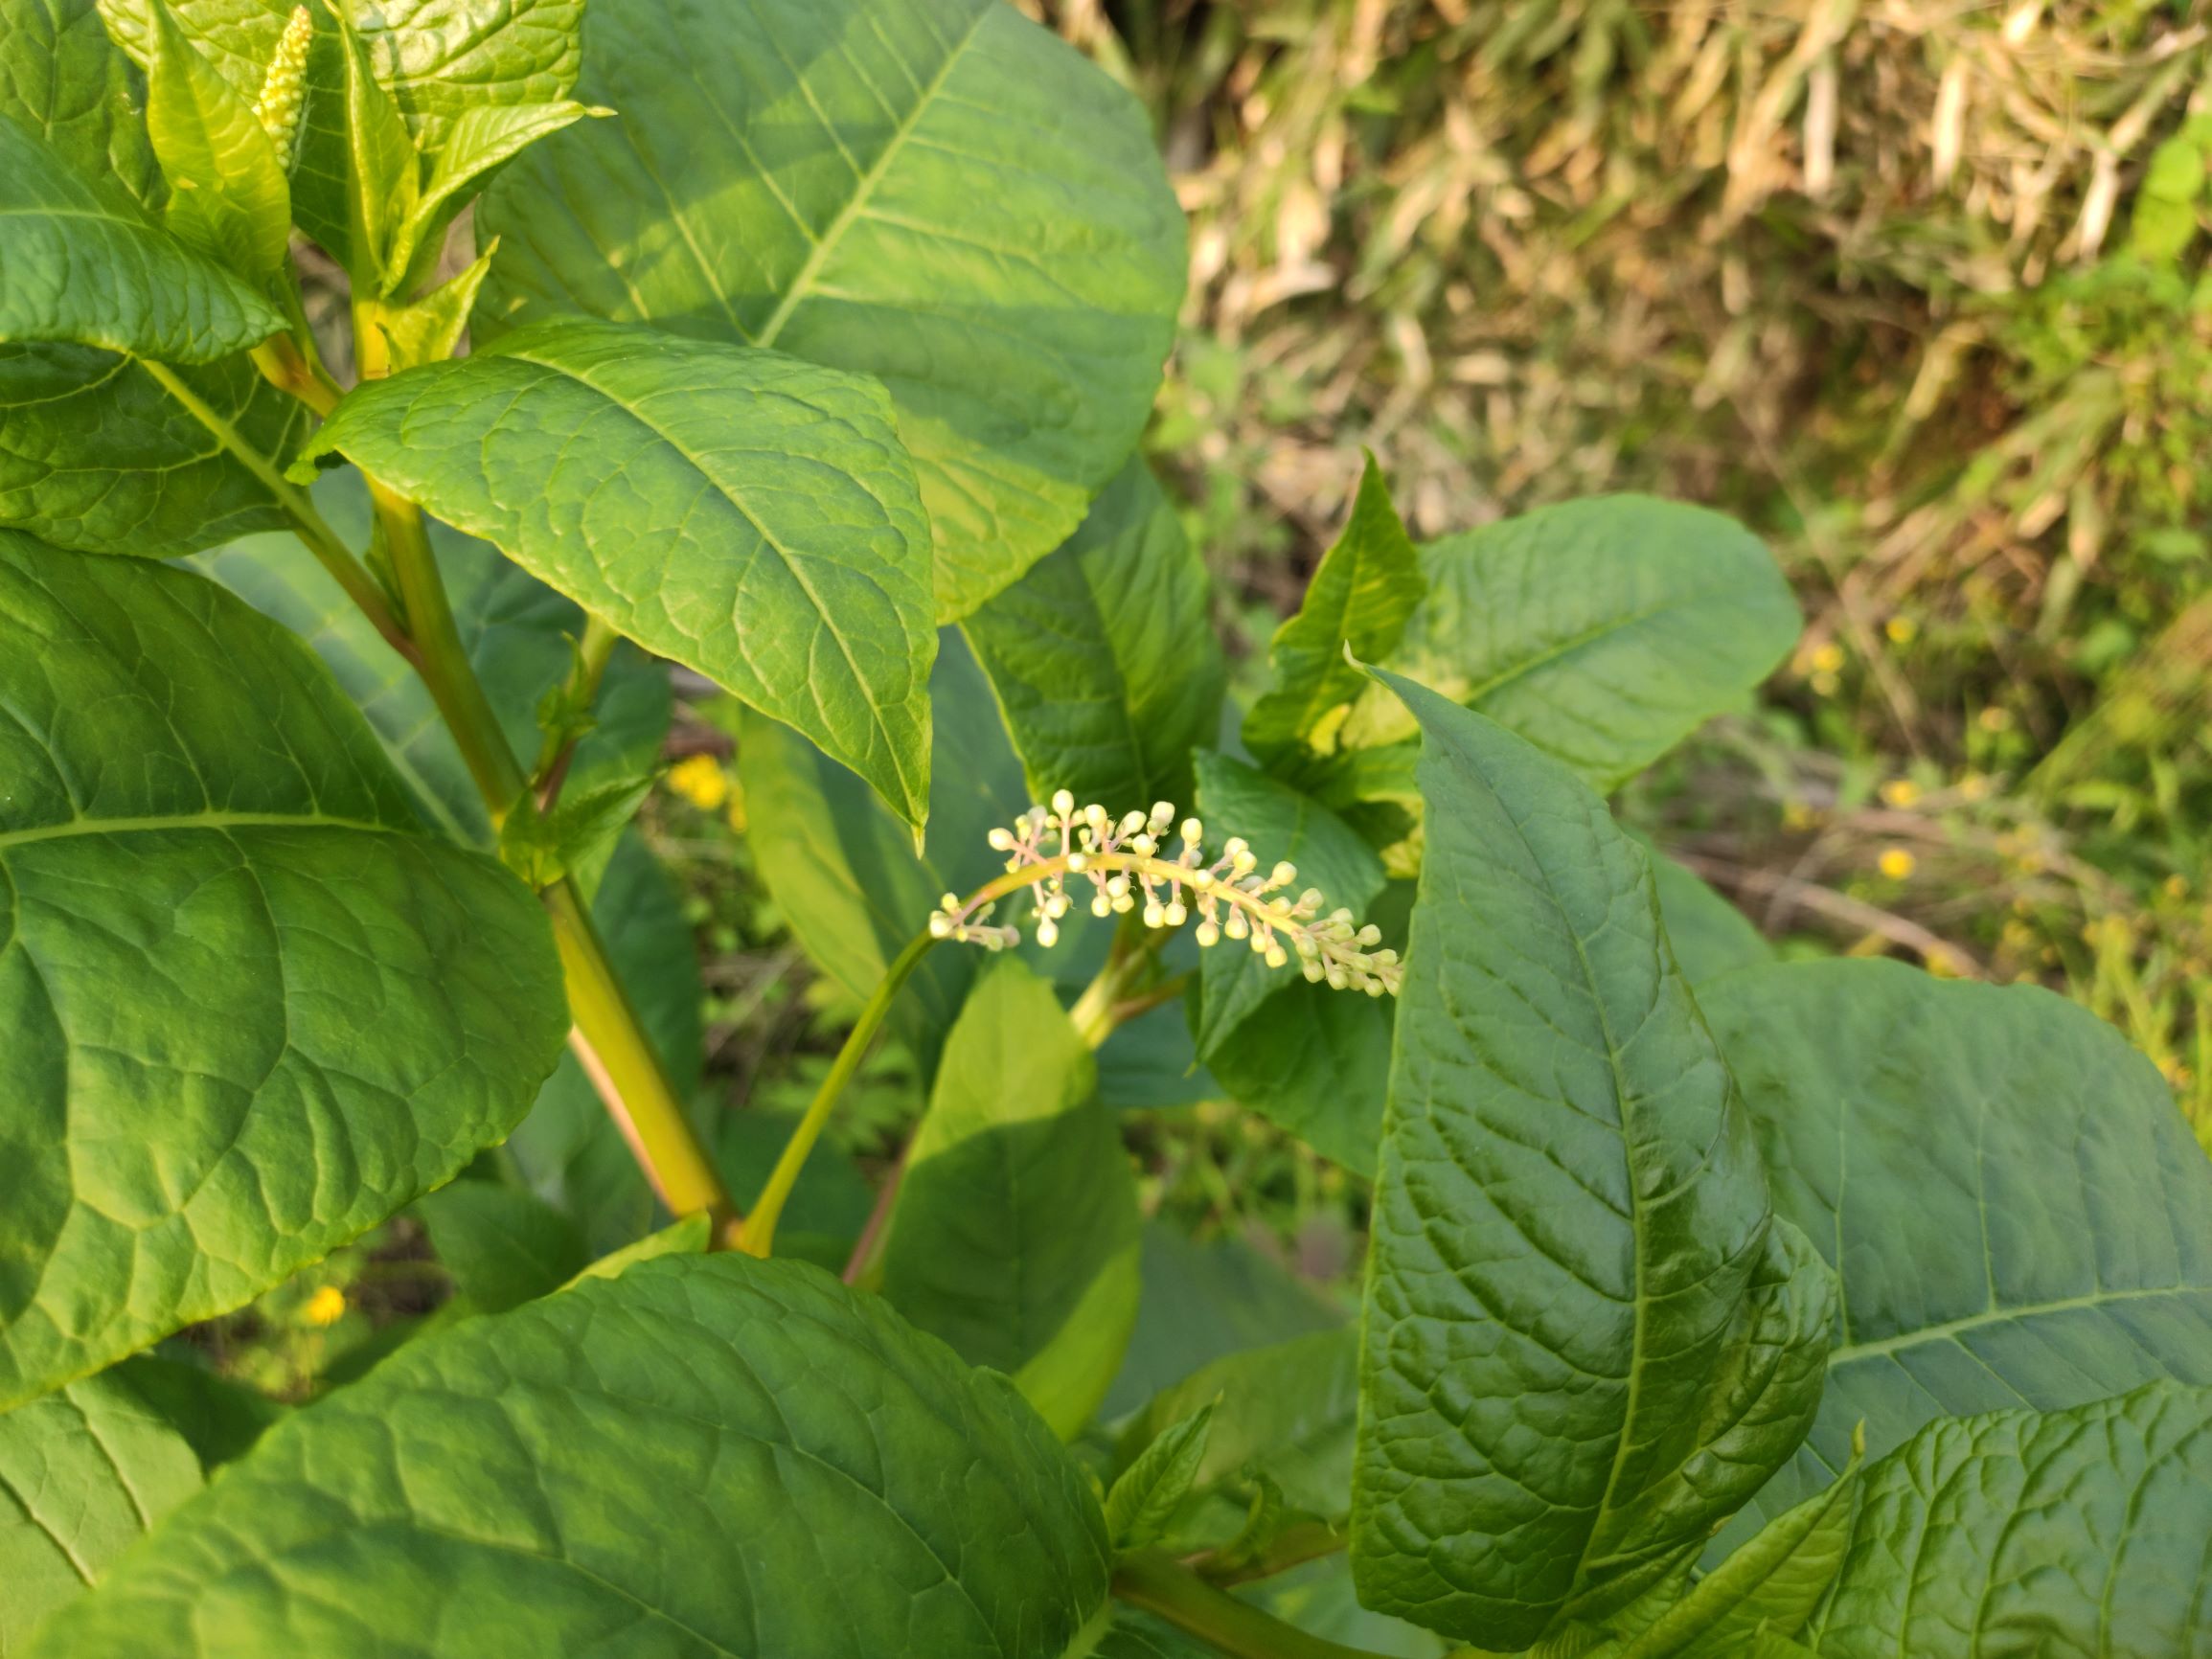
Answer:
[{"left": 1701, "top": 963, "right": 2212, "bottom": 1539}]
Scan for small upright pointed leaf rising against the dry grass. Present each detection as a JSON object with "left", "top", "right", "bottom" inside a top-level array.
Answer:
[{"left": 1243, "top": 456, "right": 1423, "bottom": 772}]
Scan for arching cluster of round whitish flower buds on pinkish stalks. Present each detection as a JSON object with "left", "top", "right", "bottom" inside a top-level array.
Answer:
[{"left": 929, "top": 789, "right": 1404, "bottom": 998}]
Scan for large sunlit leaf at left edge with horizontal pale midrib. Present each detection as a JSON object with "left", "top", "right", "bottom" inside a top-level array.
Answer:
[{"left": 0, "top": 535, "right": 568, "bottom": 1402}]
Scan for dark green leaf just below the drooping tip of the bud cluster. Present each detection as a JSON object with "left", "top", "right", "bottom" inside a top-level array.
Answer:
[{"left": 1201, "top": 982, "right": 1398, "bottom": 1179}]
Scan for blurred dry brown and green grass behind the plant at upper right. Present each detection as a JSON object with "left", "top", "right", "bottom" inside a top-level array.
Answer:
[{"left": 1019, "top": 0, "right": 2212, "bottom": 1137}]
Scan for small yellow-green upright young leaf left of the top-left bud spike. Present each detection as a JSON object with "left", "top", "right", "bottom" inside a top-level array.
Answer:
[{"left": 146, "top": 0, "right": 292, "bottom": 290}]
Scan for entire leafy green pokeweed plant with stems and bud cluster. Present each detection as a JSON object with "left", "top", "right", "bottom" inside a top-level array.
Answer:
[{"left": 0, "top": 0, "right": 2212, "bottom": 1659}]
